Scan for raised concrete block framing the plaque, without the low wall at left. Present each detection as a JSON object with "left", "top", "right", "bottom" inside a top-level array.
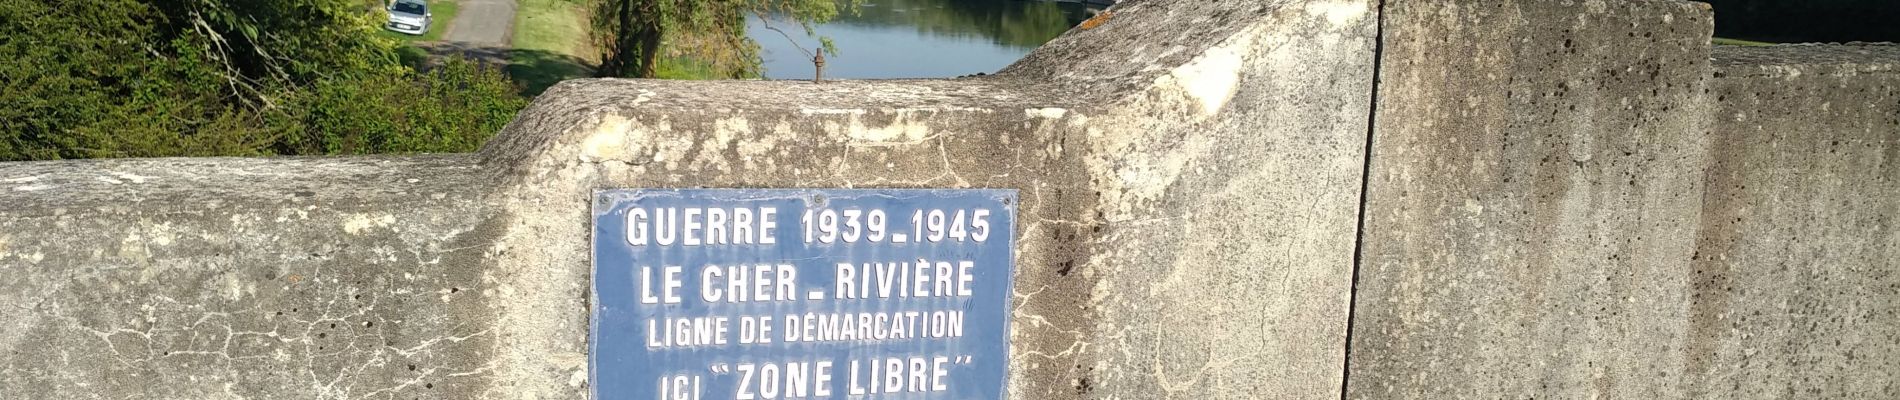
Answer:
[{"left": 483, "top": 2, "right": 1376, "bottom": 398}]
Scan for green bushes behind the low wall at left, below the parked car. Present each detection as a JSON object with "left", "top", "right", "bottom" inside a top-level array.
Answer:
[{"left": 0, "top": 0, "right": 524, "bottom": 161}]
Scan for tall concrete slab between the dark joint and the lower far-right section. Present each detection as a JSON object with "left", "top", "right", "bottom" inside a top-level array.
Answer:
[{"left": 1347, "top": 0, "right": 1712, "bottom": 398}]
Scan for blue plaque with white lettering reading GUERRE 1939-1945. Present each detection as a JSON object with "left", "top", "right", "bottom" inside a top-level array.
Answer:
[{"left": 589, "top": 190, "right": 1017, "bottom": 400}]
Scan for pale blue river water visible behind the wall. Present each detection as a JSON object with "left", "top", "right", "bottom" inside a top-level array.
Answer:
[{"left": 747, "top": 0, "right": 1091, "bottom": 80}]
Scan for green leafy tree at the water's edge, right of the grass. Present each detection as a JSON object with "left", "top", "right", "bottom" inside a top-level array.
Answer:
[{"left": 593, "top": 0, "right": 859, "bottom": 78}]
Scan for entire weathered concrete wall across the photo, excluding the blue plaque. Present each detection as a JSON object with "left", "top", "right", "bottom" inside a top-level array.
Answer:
[{"left": 0, "top": 0, "right": 1900, "bottom": 398}]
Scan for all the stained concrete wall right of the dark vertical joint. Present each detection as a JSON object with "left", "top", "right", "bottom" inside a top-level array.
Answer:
[{"left": 1347, "top": 0, "right": 1900, "bottom": 398}]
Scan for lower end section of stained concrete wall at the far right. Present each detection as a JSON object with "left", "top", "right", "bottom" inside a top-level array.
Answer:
[{"left": 1685, "top": 45, "right": 1900, "bottom": 398}]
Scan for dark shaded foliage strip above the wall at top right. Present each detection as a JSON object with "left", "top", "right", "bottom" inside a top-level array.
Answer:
[{"left": 1706, "top": 0, "right": 1900, "bottom": 44}]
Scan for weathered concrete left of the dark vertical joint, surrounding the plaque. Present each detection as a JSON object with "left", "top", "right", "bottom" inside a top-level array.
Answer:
[{"left": 0, "top": 0, "right": 1378, "bottom": 398}]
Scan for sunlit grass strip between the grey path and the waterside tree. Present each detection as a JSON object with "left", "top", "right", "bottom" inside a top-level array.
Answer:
[{"left": 507, "top": 0, "right": 595, "bottom": 97}]
